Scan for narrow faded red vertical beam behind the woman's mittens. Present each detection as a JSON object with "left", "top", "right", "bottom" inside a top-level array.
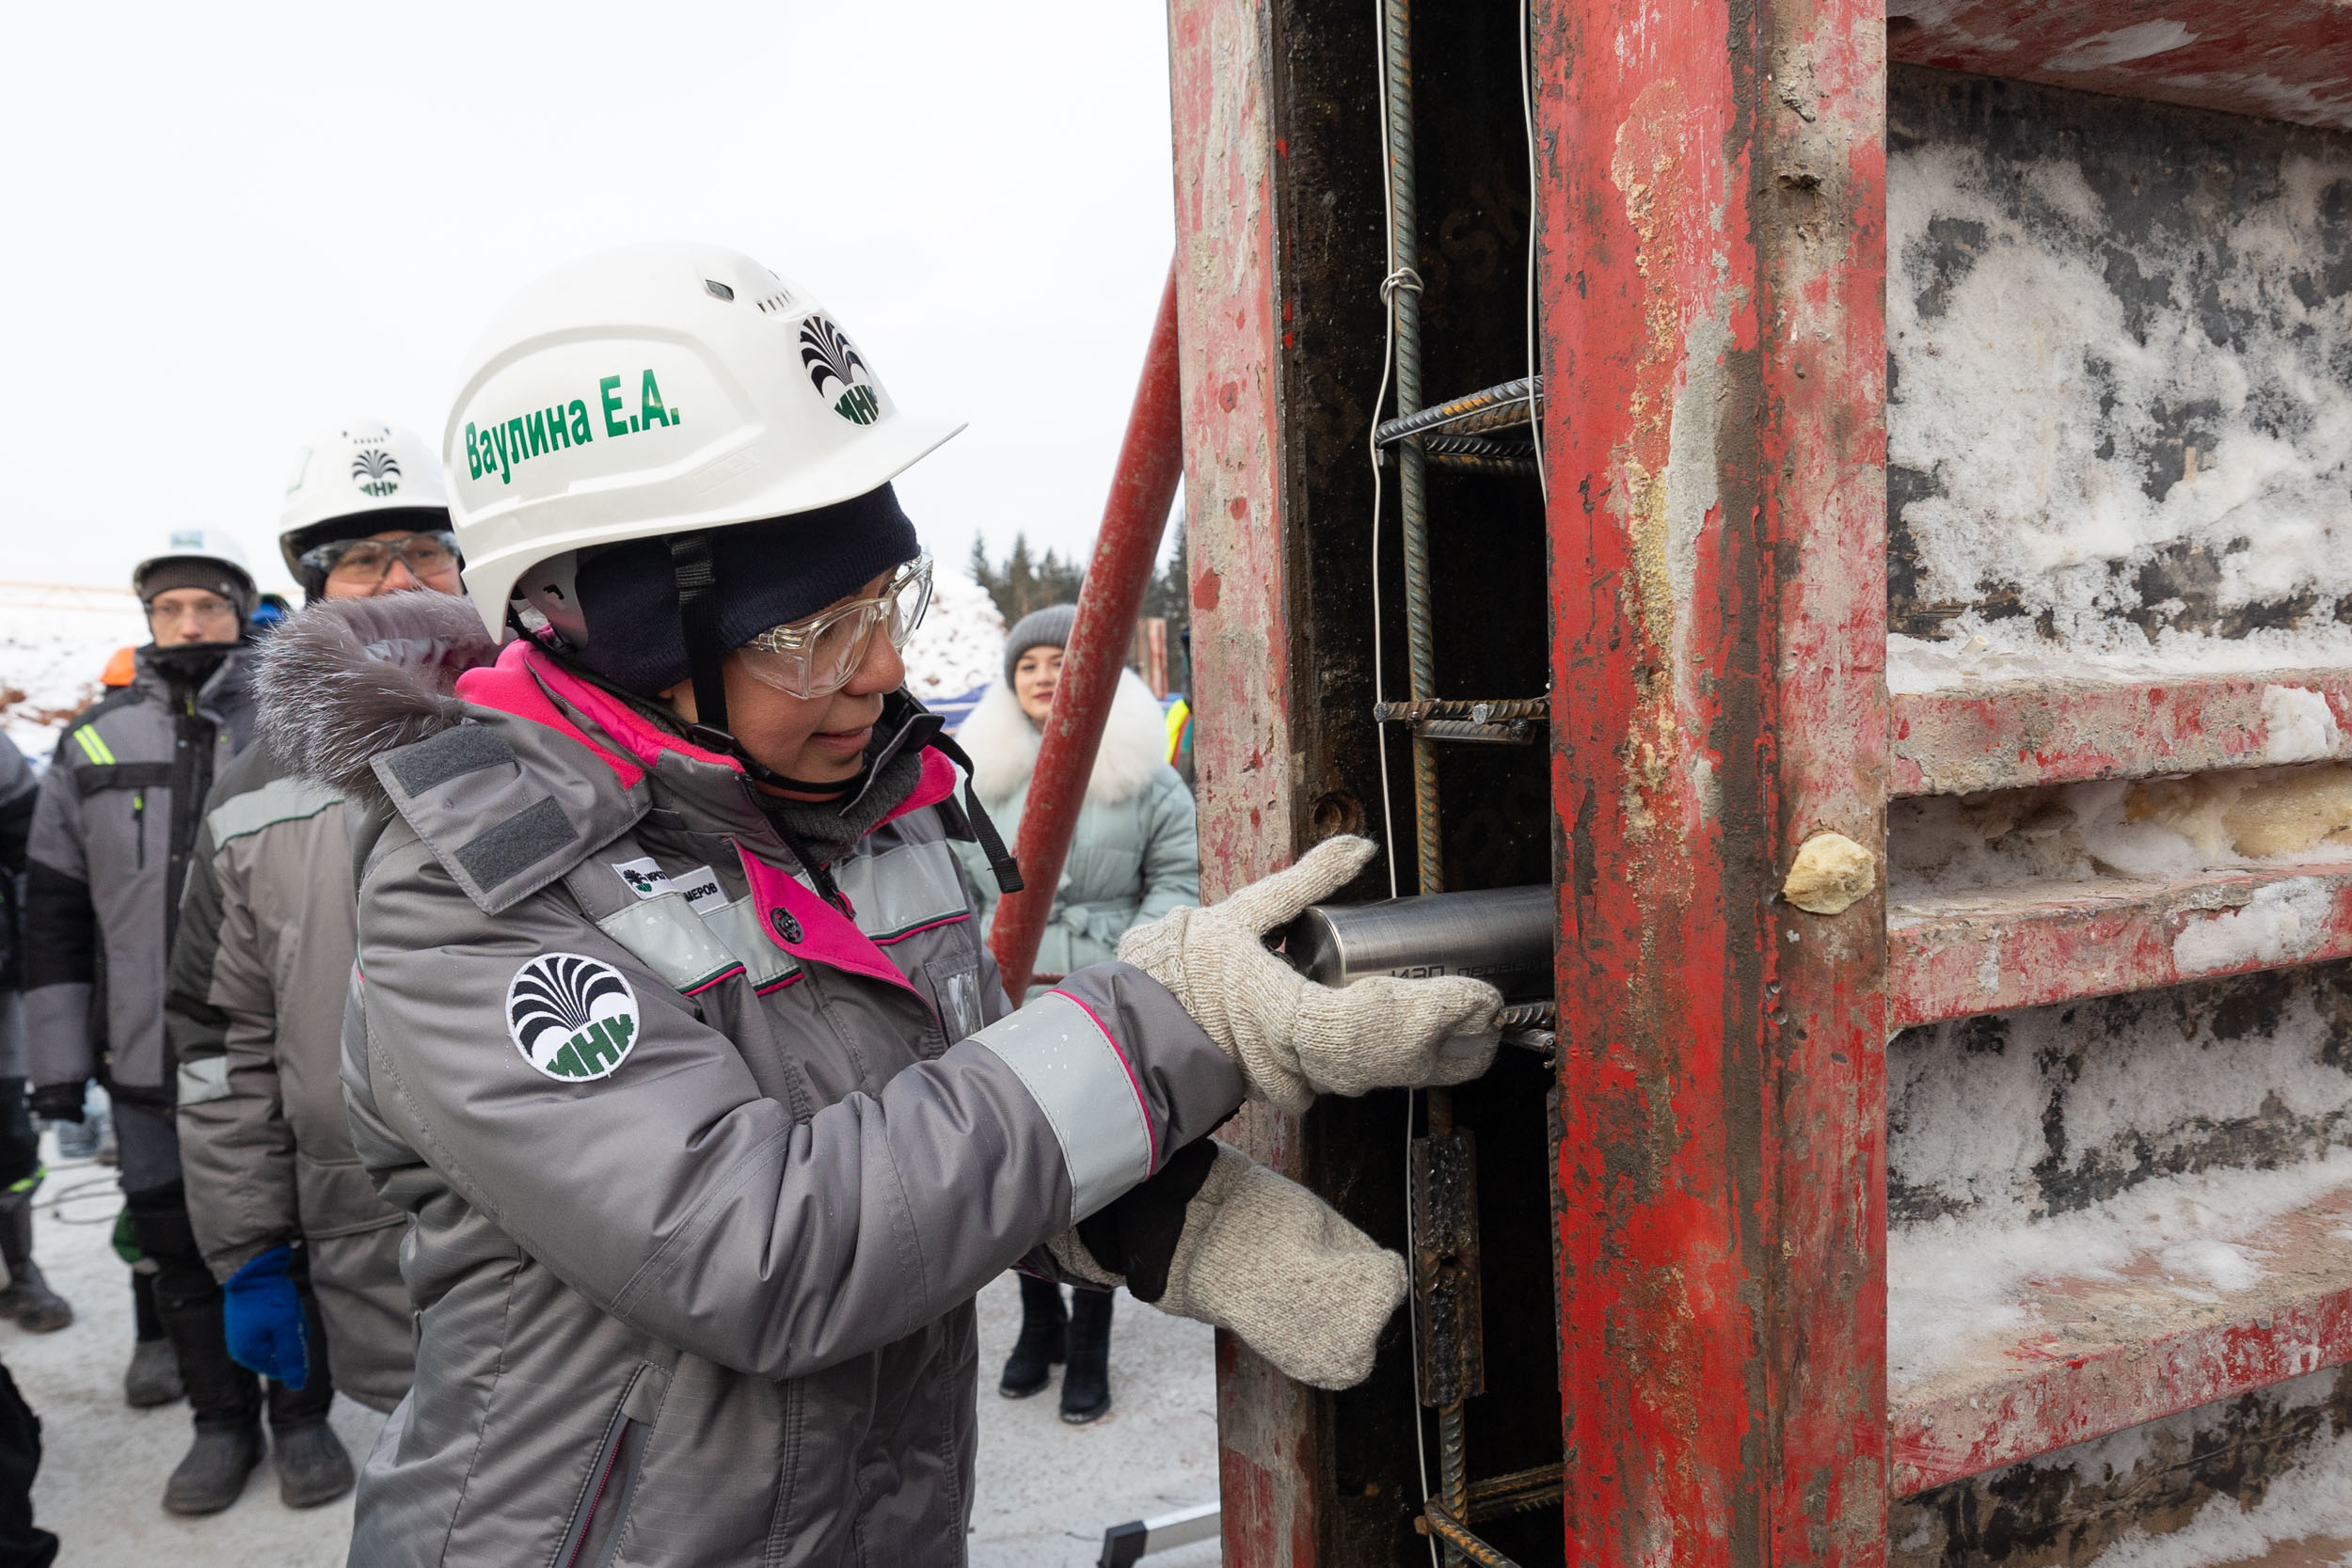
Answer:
[{"left": 1169, "top": 0, "right": 1322, "bottom": 1568}]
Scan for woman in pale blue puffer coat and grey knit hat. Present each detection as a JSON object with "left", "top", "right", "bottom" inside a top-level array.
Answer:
[{"left": 955, "top": 604, "right": 1200, "bottom": 1422}]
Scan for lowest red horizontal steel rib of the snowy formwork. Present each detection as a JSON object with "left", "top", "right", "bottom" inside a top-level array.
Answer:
[{"left": 1889, "top": 1192, "right": 2352, "bottom": 1497}]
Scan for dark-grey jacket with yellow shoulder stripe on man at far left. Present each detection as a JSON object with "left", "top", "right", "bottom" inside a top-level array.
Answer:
[{"left": 24, "top": 646, "right": 252, "bottom": 1105}]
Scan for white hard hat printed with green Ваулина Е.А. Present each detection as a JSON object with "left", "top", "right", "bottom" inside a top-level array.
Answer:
[{"left": 442, "top": 245, "right": 962, "bottom": 637}]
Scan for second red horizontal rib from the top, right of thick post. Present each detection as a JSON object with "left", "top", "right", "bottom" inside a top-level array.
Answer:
[{"left": 1891, "top": 670, "right": 2352, "bottom": 795}]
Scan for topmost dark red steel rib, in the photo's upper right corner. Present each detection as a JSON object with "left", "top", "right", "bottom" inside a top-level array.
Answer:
[{"left": 1886, "top": 0, "right": 2352, "bottom": 129}]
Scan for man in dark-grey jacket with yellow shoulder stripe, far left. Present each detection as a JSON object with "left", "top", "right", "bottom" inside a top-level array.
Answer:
[{"left": 24, "top": 529, "right": 275, "bottom": 1512}]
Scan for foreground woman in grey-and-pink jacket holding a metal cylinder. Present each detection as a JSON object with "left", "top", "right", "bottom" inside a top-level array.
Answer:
[{"left": 262, "top": 245, "right": 1499, "bottom": 1568}]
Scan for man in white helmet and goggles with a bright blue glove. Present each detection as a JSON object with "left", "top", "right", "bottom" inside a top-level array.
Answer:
[{"left": 165, "top": 420, "right": 464, "bottom": 1507}]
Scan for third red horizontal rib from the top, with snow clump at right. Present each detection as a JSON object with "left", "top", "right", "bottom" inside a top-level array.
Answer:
[{"left": 1886, "top": 863, "right": 2352, "bottom": 1030}]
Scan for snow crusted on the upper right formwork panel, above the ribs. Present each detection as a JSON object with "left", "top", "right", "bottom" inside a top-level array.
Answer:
[{"left": 1886, "top": 110, "right": 2352, "bottom": 691}]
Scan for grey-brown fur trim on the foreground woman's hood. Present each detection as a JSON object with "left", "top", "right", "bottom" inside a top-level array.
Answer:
[{"left": 254, "top": 590, "right": 499, "bottom": 806}]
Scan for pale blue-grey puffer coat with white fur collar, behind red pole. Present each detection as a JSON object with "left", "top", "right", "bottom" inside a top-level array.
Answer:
[{"left": 955, "top": 670, "right": 1200, "bottom": 975}]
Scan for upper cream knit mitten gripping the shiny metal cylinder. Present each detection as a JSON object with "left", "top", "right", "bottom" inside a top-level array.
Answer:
[{"left": 1120, "top": 834, "right": 1503, "bottom": 1112}]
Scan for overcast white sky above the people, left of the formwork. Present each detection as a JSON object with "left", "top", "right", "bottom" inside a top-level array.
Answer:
[{"left": 0, "top": 0, "right": 1174, "bottom": 601}]
